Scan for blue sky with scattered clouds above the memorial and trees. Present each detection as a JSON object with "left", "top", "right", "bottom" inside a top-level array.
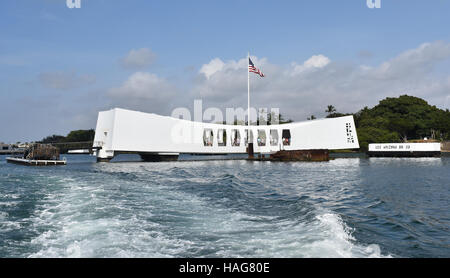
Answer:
[{"left": 0, "top": 0, "right": 450, "bottom": 143}]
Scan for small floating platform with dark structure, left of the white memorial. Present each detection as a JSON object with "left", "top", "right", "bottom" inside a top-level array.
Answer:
[{"left": 6, "top": 144, "right": 66, "bottom": 166}]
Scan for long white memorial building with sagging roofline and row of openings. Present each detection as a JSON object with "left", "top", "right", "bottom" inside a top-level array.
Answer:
[{"left": 94, "top": 108, "right": 359, "bottom": 157}]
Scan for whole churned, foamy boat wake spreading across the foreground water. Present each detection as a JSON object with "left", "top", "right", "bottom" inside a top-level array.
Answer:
[{"left": 21, "top": 163, "right": 383, "bottom": 258}]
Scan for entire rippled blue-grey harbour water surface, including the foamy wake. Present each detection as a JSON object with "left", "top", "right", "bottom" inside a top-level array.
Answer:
[{"left": 0, "top": 155, "right": 450, "bottom": 258}]
